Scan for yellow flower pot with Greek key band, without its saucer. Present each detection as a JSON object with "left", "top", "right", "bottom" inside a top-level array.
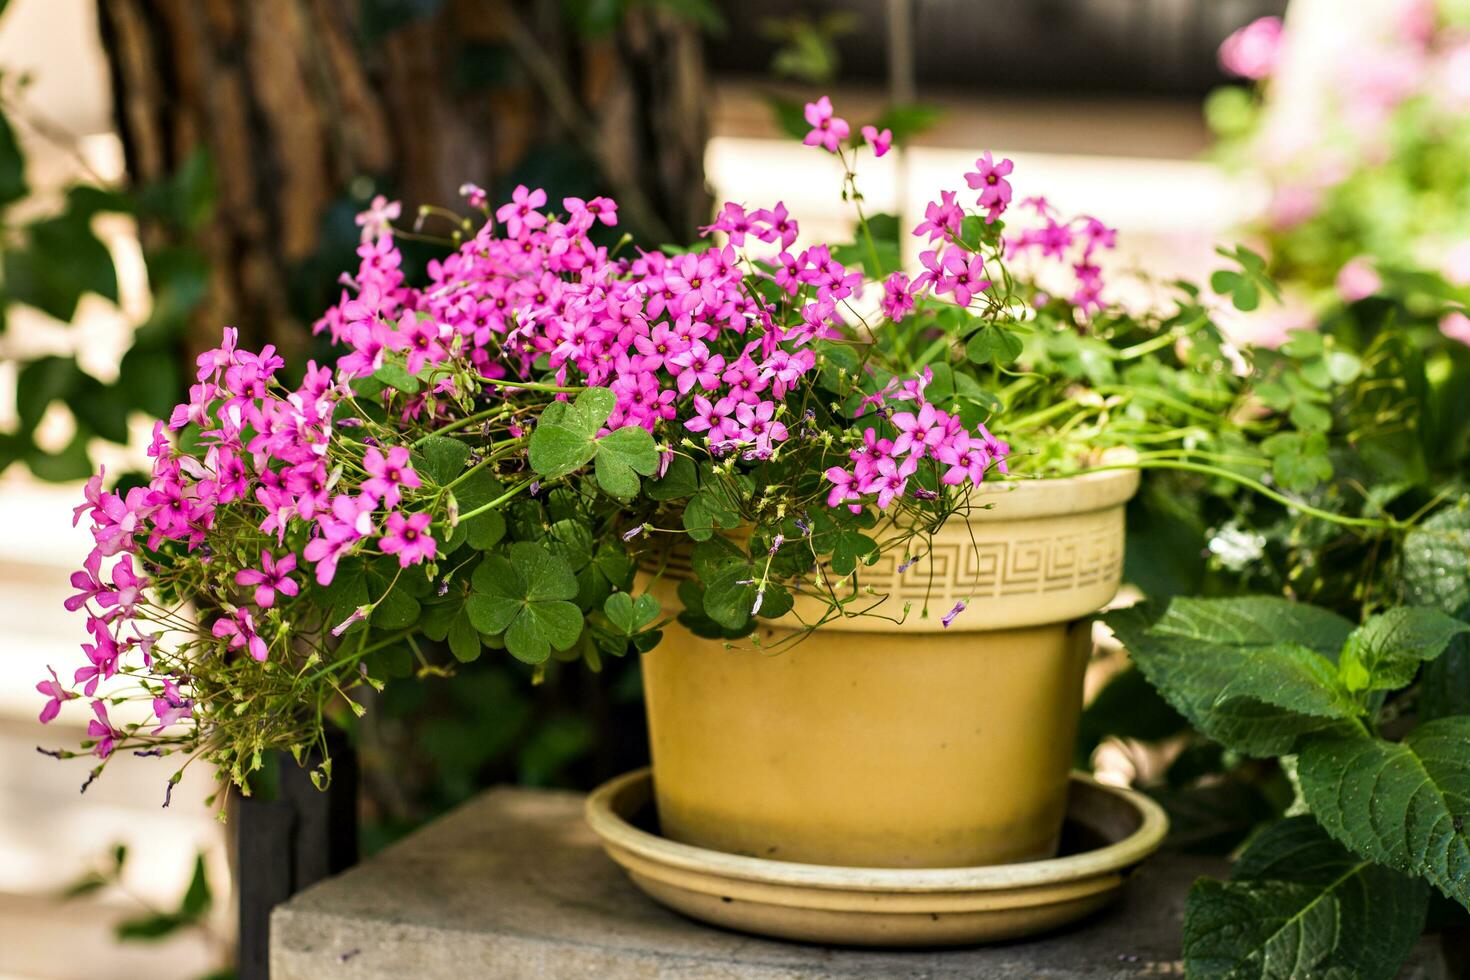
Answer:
[{"left": 642, "top": 470, "right": 1138, "bottom": 868}]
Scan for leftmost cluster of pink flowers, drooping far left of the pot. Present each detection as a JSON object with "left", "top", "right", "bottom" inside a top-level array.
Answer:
[{"left": 51, "top": 326, "right": 435, "bottom": 757}]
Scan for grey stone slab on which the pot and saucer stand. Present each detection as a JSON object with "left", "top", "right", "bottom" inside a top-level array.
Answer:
[{"left": 270, "top": 789, "right": 1449, "bottom": 980}]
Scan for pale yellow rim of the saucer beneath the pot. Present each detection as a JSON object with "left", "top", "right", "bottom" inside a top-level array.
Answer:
[{"left": 585, "top": 767, "right": 1169, "bottom": 893}]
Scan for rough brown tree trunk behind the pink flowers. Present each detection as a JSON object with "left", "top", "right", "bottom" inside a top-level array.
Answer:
[{"left": 98, "top": 0, "right": 710, "bottom": 358}]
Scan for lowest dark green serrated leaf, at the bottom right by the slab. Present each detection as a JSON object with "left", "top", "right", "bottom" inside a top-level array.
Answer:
[{"left": 1183, "top": 817, "right": 1429, "bottom": 980}]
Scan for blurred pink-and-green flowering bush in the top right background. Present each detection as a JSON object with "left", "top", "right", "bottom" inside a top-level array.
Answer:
[{"left": 1205, "top": 0, "right": 1470, "bottom": 301}]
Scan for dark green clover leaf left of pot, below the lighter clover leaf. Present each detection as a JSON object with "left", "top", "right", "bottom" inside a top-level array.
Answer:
[{"left": 465, "top": 541, "right": 582, "bottom": 664}]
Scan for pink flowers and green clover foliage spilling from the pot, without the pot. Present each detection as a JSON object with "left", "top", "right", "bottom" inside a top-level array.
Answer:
[{"left": 40, "top": 89, "right": 1394, "bottom": 805}]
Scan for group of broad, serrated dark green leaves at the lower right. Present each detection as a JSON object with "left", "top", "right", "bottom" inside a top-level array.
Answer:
[{"left": 1105, "top": 597, "right": 1470, "bottom": 977}]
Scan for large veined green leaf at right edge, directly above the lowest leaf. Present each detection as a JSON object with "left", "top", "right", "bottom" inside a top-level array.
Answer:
[{"left": 1297, "top": 716, "right": 1470, "bottom": 908}]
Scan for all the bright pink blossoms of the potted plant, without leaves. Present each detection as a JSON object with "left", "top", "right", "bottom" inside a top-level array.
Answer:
[{"left": 51, "top": 98, "right": 1040, "bottom": 757}]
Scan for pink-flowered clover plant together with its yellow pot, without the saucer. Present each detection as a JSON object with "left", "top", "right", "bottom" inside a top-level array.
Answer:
[{"left": 38, "top": 98, "right": 1334, "bottom": 865}]
